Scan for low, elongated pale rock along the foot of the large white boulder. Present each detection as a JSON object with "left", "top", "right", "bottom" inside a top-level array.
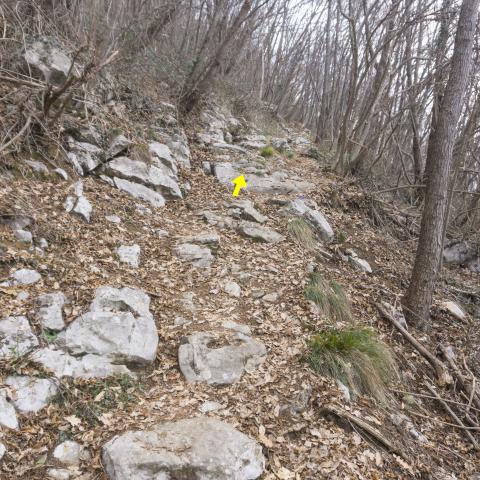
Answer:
[{"left": 30, "top": 346, "right": 132, "bottom": 379}]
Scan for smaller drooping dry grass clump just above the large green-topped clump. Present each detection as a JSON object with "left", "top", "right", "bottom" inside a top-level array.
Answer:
[{"left": 305, "top": 272, "right": 352, "bottom": 322}]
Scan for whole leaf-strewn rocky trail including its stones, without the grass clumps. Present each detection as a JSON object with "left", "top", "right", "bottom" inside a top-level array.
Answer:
[{"left": 0, "top": 78, "right": 478, "bottom": 480}]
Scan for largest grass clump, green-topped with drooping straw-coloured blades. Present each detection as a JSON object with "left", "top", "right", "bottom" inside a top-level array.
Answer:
[{"left": 305, "top": 327, "right": 398, "bottom": 402}]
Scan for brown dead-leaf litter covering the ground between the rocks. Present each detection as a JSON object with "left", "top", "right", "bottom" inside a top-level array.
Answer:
[{"left": 0, "top": 124, "right": 480, "bottom": 480}]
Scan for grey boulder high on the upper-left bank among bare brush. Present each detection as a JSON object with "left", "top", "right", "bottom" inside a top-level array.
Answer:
[{"left": 23, "top": 35, "right": 72, "bottom": 86}]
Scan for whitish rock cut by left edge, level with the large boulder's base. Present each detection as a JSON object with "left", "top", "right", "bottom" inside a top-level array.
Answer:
[{"left": 0, "top": 317, "right": 38, "bottom": 358}]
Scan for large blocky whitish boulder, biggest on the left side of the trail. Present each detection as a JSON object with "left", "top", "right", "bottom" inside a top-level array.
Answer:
[{"left": 57, "top": 287, "right": 158, "bottom": 364}]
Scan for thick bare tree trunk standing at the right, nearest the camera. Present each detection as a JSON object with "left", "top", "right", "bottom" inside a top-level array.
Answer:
[{"left": 403, "top": 0, "right": 480, "bottom": 326}]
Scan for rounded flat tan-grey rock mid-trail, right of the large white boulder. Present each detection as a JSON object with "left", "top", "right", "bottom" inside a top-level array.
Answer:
[{"left": 178, "top": 332, "right": 267, "bottom": 385}]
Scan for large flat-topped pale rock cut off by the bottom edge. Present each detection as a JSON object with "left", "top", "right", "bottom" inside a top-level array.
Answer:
[{"left": 103, "top": 417, "right": 265, "bottom": 480}]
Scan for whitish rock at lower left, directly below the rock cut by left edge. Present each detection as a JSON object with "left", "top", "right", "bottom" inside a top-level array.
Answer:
[{"left": 5, "top": 376, "right": 58, "bottom": 413}]
